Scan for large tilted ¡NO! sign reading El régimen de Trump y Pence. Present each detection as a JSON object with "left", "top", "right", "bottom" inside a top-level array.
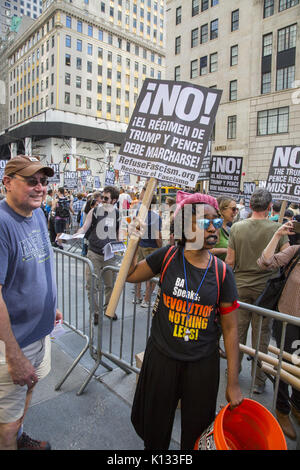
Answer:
[{"left": 115, "top": 79, "right": 222, "bottom": 187}]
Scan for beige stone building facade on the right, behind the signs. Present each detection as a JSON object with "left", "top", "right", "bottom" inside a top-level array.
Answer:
[{"left": 166, "top": 0, "right": 300, "bottom": 181}]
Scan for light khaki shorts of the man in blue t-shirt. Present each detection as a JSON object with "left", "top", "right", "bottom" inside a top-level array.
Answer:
[{"left": 0, "top": 336, "right": 51, "bottom": 423}]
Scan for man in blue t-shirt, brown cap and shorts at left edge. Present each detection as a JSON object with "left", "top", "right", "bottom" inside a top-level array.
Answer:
[{"left": 0, "top": 155, "right": 62, "bottom": 450}]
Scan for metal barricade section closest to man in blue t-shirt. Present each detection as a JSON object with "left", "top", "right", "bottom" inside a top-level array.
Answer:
[{"left": 53, "top": 248, "right": 111, "bottom": 395}]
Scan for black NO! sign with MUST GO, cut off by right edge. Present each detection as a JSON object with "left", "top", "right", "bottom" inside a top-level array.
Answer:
[{"left": 266, "top": 146, "right": 300, "bottom": 203}]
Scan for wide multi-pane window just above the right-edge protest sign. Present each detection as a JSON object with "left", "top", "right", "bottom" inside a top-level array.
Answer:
[{"left": 257, "top": 106, "right": 289, "bottom": 136}]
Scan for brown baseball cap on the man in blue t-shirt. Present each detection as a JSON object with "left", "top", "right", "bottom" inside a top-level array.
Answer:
[{"left": 4, "top": 155, "right": 54, "bottom": 176}]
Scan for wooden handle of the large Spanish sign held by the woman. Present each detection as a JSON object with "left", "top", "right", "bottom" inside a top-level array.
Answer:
[{"left": 105, "top": 178, "right": 157, "bottom": 318}]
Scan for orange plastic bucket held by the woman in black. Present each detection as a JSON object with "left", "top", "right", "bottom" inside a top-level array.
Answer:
[{"left": 194, "top": 398, "right": 287, "bottom": 450}]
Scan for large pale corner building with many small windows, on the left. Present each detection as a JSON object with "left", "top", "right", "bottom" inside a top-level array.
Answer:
[{"left": 0, "top": 0, "right": 165, "bottom": 184}]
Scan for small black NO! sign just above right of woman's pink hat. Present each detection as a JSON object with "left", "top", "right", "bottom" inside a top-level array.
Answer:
[{"left": 209, "top": 155, "right": 243, "bottom": 198}]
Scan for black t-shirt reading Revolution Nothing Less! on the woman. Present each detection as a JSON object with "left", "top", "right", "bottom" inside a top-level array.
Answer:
[{"left": 146, "top": 246, "right": 238, "bottom": 361}]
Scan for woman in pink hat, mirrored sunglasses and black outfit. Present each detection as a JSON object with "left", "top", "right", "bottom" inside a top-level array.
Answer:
[{"left": 127, "top": 191, "right": 242, "bottom": 450}]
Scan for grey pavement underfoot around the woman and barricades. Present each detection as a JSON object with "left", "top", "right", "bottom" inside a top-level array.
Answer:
[{"left": 24, "top": 331, "right": 300, "bottom": 451}]
